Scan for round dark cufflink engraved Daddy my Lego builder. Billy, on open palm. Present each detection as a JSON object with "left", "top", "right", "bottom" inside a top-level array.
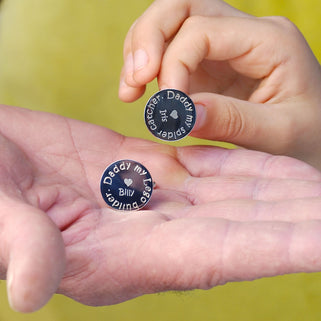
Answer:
[{"left": 100, "top": 159, "right": 154, "bottom": 211}]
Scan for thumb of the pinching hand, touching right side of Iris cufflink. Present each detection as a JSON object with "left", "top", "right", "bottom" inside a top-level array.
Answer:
[{"left": 191, "top": 93, "right": 291, "bottom": 153}]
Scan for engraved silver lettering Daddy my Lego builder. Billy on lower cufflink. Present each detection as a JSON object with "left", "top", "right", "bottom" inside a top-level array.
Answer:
[{"left": 103, "top": 162, "right": 153, "bottom": 210}]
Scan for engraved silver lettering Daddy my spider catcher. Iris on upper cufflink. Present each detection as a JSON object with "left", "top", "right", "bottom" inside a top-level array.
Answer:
[{"left": 146, "top": 90, "right": 194, "bottom": 139}]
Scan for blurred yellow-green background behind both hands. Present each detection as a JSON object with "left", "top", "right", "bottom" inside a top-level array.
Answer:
[{"left": 0, "top": 0, "right": 321, "bottom": 321}]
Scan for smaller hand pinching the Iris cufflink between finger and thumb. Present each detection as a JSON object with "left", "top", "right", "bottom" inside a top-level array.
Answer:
[{"left": 119, "top": 0, "right": 321, "bottom": 169}]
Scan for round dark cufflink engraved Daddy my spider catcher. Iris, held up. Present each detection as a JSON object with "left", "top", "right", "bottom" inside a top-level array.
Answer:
[{"left": 144, "top": 89, "right": 196, "bottom": 141}]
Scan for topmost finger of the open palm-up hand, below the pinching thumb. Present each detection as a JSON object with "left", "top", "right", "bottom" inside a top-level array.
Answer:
[{"left": 177, "top": 146, "right": 321, "bottom": 182}]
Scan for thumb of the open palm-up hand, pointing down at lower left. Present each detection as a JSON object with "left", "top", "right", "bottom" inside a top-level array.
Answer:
[{"left": 0, "top": 200, "right": 65, "bottom": 312}]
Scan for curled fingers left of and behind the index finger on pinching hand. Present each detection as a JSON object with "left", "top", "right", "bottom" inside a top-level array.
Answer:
[{"left": 119, "top": 0, "right": 248, "bottom": 101}]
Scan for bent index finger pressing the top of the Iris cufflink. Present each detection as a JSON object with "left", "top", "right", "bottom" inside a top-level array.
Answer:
[{"left": 159, "top": 16, "right": 286, "bottom": 92}]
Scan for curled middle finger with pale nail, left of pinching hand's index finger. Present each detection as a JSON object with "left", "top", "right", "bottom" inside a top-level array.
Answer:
[{"left": 122, "top": 1, "right": 188, "bottom": 97}]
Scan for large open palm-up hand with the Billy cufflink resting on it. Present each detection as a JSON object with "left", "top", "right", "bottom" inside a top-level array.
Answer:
[{"left": 0, "top": 106, "right": 321, "bottom": 312}]
